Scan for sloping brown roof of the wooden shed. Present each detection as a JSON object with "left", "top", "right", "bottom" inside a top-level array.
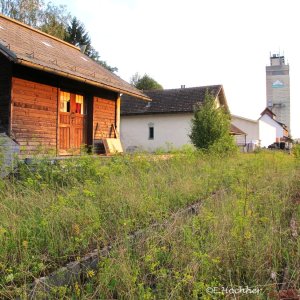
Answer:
[{"left": 0, "top": 14, "right": 150, "bottom": 100}]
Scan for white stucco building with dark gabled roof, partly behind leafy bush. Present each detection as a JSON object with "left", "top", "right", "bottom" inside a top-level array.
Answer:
[{"left": 120, "top": 85, "right": 243, "bottom": 151}]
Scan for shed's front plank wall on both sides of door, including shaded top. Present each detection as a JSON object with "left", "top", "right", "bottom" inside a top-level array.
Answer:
[{"left": 11, "top": 65, "right": 118, "bottom": 156}]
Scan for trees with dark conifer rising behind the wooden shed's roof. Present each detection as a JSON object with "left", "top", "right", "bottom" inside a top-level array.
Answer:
[{"left": 0, "top": 0, "right": 118, "bottom": 72}]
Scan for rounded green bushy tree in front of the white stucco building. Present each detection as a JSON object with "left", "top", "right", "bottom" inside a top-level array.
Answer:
[{"left": 189, "top": 92, "right": 234, "bottom": 149}]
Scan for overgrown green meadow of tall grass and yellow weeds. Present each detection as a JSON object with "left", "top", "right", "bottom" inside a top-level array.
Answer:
[{"left": 0, "top": 150, "right": 300, "bottom": 299}]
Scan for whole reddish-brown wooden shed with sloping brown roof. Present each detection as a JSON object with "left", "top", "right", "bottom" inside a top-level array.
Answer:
[{"left": 0, "top": 15, "right": 149, "bottom": 155}]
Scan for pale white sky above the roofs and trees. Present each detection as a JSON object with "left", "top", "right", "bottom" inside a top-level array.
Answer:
[{"left": 52, "top": 0, "right": 300, "bottom": 137}]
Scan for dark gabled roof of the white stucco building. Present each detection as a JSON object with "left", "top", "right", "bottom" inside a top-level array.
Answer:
[{"left": 121, "top": 85, "right": 229, "bottom": 115}]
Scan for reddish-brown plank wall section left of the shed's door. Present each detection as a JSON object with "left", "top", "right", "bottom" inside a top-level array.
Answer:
[{"left": 11, "top": 77, "right": 58, "bottom": 154}]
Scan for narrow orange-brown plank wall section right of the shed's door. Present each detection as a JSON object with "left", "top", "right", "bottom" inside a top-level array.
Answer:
[{"left": 93, "top": 97, "right": 116, "bottom": 140}]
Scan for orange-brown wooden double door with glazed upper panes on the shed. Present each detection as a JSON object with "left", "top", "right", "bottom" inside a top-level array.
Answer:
[{"left": 59, "top": 91, "right": 86, "bottom": 155}]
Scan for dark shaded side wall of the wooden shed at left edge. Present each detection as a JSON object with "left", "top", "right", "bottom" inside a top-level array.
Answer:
[{"left": 0, "top": 55, "right": 12, "bottom": 133}]
